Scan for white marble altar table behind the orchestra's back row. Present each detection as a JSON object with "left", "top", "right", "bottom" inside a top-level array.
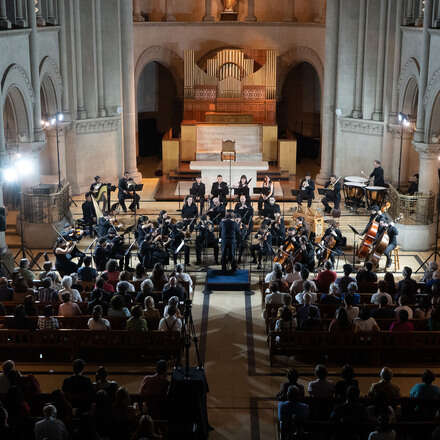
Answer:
[{"left": 189, "top": 160, "right": 269, "bottom": 193}]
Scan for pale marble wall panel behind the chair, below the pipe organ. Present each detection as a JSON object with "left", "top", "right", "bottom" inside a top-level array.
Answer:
[{"left": 196, "top": 124, "right": 263, "bottom": 162}]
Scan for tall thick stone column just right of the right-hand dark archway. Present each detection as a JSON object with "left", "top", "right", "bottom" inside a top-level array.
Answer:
[{"left": 316, "top": 0, "right": 340, "bottom": 184}]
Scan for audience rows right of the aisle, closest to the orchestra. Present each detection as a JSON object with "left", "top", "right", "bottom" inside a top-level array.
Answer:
[{"left": 263, "top": 261, "right": 440, "bottom": 333}]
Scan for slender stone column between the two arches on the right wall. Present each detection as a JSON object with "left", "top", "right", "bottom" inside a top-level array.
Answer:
[{"left": 414, "top": 0, "right": 432, "bottom": 142}]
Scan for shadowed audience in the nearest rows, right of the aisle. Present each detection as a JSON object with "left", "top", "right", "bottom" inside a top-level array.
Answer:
[{"left": 276, "top": 364, "right": 440, "bottom": 440}]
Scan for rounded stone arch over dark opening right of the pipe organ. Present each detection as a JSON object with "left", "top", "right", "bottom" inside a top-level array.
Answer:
[{"left": 277, "top": 46, "right": 324, "bottom": 93}]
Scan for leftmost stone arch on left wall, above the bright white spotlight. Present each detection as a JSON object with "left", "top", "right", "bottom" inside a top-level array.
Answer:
[{"left": 0, "top": 64, "right": 35, "bottom": 142}]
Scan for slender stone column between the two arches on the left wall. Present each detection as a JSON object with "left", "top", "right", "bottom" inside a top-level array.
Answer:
[{"left": 27, "top": 0, "right": 44, "bottom": 141}]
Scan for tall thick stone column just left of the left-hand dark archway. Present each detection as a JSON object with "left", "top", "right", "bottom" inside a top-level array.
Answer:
[{"left": 120, "top": 1, "right": 139, "bottom": 178}]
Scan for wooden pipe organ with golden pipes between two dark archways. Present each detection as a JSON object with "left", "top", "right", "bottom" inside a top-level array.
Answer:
[{"left": 184, "top": 49, "right": 277, "bottom": 123}]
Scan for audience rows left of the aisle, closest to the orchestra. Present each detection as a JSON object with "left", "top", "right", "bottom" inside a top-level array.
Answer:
[{"left": 0, "top": 257, "right": 193, "bottom": 332}]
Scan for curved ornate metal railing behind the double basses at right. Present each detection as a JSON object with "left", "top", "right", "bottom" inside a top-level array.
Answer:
[{"left": 388, "top": 185, "right": 435, "bottom": 225}]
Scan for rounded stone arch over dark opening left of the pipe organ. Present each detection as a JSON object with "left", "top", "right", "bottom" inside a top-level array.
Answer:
[{"left": 134, "top": 46, "right": 184, "bottom": 97}]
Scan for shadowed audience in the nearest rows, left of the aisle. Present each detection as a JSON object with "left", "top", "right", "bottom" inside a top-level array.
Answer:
[{"left": 0, "top": 359, "right": 170, "bottom": 440}]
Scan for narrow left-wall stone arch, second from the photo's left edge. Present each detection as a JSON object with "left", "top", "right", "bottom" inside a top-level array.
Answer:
[{"left": 39, "top": 56, "right": 63, "bottom": 116}]
